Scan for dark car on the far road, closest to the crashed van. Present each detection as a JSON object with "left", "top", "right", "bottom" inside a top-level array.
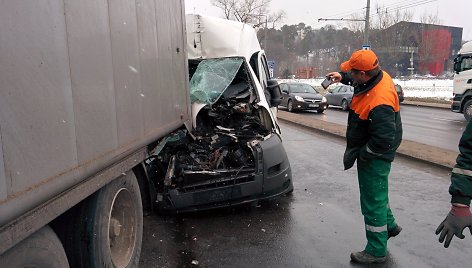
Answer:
[{"left": 280, "top": 83, "right": 328, "bottom": 113}]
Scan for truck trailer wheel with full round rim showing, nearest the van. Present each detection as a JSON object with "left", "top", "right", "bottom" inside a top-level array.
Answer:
[{"left": 66, "top": 171, "right": 143, "bottom": 268}]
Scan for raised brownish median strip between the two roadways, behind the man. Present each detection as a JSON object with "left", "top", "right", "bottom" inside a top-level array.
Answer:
[{"left": 277, "top": 110, "right": 458, "bottom": 170}]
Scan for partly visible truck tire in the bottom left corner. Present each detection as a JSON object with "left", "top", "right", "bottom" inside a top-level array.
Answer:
[{"left": 0, "top": 226, "right": 69, "bottom": 268}]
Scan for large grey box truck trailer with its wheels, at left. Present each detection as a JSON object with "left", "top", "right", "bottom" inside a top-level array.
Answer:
[{"left": 0, "top": 0, "right": 190, "bottom": 268}]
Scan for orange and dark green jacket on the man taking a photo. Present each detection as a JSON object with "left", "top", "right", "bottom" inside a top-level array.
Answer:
[{"left": 341, "top": 71, "right": 403, "bottom": 169}]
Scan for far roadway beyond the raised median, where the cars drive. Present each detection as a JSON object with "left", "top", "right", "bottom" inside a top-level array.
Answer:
[{"left": 282, "top": 105, "right": 467, "bottom": 152}]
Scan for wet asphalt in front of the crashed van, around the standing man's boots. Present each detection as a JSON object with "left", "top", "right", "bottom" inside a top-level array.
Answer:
[{"left": 140, "top": 124, "right": 472, "bottom": 268}]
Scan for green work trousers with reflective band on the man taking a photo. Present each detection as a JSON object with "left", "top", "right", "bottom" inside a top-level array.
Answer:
[{"left": 357, "top": 159, "right": 397, "bottom": 257}]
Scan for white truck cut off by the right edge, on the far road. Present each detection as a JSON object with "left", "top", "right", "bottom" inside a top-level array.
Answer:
[{"left": 451, "top": 41, "right": 472, "bottom": 121}]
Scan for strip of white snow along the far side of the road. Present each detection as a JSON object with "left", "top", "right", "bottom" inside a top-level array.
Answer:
[{"left": 278, "top": 78, "right": 453, "bottom": 100}]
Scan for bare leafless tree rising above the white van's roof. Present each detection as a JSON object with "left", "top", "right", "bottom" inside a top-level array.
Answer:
[{"left": 211, "top": 0, "right": 285, "bottom": 28}]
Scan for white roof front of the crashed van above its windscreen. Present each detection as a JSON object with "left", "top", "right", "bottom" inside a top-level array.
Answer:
[{"left": 186, "top": 14, "right": 262, "bottom": 60}]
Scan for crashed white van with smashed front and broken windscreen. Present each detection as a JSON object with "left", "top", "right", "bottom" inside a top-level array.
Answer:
[{"left": 147, "top": 15, "right": 293, "bottom": 212}]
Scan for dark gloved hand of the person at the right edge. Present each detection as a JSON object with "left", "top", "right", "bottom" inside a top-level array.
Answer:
[{"left": 436, "top": 204, "right": 472, "bottom": 248}]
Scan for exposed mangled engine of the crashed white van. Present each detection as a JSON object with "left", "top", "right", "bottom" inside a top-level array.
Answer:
[{"left": 147, "top": 57, "right": 271, "bottom": 193}]
